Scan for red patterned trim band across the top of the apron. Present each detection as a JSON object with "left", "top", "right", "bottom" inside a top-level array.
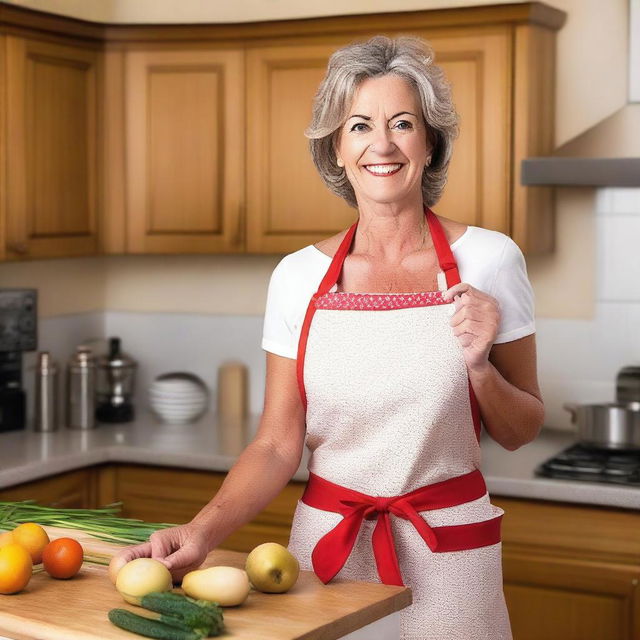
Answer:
[{"left": 315, "top": 291, "right": 448, "bottom": 311}]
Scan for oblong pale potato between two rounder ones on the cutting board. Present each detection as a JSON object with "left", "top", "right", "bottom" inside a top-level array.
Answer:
[{"left": 182, "top": 567, "right": 251, "bottom": 607}]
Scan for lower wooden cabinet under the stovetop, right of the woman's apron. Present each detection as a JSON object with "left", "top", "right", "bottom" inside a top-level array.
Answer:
[{"left": 492, "top": 497, "right": 640, "bottom": 640}]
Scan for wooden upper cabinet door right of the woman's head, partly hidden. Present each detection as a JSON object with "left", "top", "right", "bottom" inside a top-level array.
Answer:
[{"left": 418, "top": 27, "right": 511, "bottom": 234}]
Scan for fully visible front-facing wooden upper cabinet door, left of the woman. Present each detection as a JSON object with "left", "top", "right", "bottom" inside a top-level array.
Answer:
[{"left": 125, "top": 48, "right": 245, "bottom": 253}]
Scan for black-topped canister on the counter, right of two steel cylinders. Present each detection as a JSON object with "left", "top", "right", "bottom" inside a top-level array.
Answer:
[{"left": 96, "top": 338, "right": 138, "bottom": 422}]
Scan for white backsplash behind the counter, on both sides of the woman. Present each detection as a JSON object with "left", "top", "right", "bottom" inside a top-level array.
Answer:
[{"left": 25, "top": 189, "right": 640, "bottom": 429}]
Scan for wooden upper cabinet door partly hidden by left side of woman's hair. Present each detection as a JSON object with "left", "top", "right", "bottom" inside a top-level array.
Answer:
[{"left": 247, "top": 43, "right": 357, "bottom": 253}]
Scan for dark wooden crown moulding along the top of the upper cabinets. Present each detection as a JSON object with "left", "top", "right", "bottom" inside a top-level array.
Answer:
[{"left": 0, "top": 2, "right": 566, "bottom": 43}]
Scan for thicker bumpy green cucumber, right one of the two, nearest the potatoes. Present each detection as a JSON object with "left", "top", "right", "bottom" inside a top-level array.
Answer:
[{"left": 140, "top": 591, "right": 224, "bottom": 637}]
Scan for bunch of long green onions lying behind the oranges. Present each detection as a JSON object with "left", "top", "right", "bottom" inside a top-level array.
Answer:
[{"left": 0, "top": 500, "right": 176, "bottom": 544}]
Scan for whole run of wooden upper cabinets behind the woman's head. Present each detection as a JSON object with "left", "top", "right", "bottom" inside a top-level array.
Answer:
[{"left": 0, "top": 3, "right": 564, "bottom": 259}]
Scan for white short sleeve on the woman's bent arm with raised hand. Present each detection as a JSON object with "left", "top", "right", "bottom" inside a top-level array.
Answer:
[{"left": 491, "top": 238, "right": 536, "bottom": 344}]
